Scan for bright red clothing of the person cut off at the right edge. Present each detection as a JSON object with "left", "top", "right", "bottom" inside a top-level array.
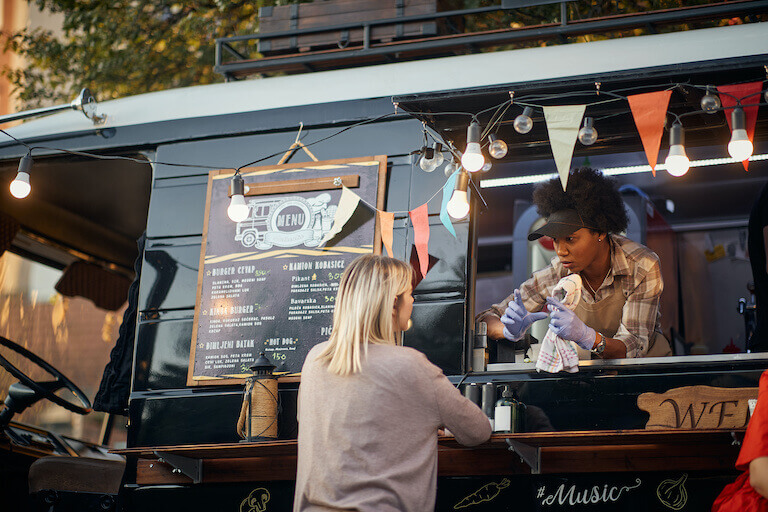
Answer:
[{"left": 712, "top": 370, "right": 768, "bottom": 512}]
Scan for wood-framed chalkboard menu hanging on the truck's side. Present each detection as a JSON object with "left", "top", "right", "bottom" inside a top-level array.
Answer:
[{"left": 187, "top": 156, "right": 387, "bottom": 385}]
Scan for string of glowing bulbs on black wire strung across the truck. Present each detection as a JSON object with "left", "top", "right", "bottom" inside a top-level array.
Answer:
[{"left": 0, "top": 79, "right": 768, "bottom": 220}]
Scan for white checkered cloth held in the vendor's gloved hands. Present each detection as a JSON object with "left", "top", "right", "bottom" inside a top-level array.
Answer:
[{"left": 536, "top": 274, "right": 582, "bottom": 373}]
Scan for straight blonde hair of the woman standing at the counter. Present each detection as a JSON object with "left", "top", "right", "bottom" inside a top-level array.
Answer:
[{"left": 318, "top": 254, "right": 413, "bottom": 375}]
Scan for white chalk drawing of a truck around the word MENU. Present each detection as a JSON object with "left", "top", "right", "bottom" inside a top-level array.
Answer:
[{"left": 235, "top": 193, "right": 337, "bottom": 250}]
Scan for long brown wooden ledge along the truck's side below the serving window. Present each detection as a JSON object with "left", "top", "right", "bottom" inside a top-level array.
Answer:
[{"left": 113, "top": 429, "right": 744, "bottom": 485}]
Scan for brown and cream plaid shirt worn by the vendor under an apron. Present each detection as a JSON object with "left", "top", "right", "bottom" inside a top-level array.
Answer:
[{"left": 488, "top": 235, "right": 664, "bottom": 357}]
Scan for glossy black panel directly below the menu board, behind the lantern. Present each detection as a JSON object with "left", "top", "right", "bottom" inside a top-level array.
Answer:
[{"left": 128, "top": 385, "right": 298, "bottom": 447}]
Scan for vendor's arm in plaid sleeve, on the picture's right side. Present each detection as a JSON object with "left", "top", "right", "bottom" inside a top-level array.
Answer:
[{"left": 605, "top": 259, "right": 664, "bottom": 358}]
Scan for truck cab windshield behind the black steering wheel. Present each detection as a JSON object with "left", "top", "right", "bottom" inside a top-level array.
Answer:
[{"left": 0, "top": 252, "right": 125, "bottom": 446}]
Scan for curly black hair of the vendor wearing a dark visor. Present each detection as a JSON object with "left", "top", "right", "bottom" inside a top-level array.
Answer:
[{"left": 533, "top": 167, "right": 629, "bottom": 233}]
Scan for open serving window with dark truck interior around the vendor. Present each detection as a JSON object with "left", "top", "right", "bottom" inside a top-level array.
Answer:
[{"left": 395, "top": 58, "right": 768, "bottom": 370}]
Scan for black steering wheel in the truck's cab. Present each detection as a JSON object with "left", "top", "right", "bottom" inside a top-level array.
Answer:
[{"left": 0, "top": 336, "right": 91, "bottom": 414}]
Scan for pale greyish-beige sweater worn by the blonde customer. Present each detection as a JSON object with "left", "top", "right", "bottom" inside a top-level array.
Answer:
[{"left": 293, "top": 342, "right": 491, "bottom": 512}]
